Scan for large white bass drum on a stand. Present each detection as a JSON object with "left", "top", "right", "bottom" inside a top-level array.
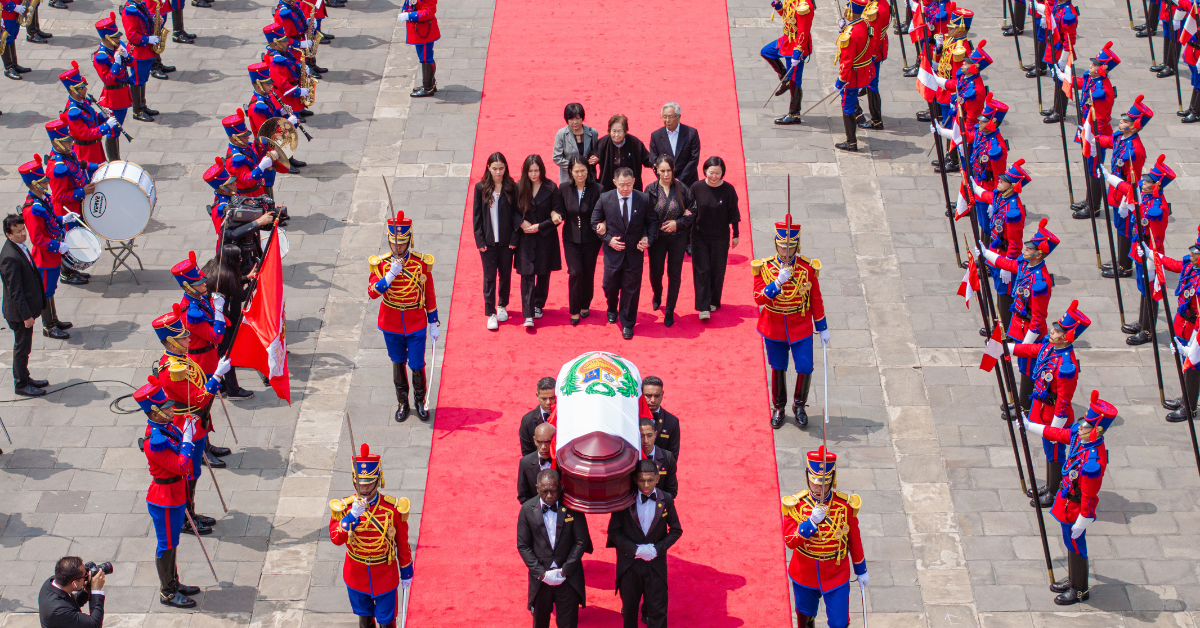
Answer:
[{"left": 83, "top": 161, "right": 157, "bottom": 240}]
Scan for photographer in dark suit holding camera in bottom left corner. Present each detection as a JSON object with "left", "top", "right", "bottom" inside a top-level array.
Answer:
[{"left": 37, "top": 556, "right": 113, "bottom": 628}]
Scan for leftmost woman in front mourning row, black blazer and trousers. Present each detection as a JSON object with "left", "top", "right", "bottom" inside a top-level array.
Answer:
[{"left": 472, "top": 152, "right": 521, "bottom": 331}]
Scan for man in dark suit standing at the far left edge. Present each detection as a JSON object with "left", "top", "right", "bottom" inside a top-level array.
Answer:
[{"left": 0, "top": 214, "right": 49, "bottom": 397}]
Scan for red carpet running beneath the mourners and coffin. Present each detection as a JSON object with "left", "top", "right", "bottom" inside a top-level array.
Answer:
[{"left": 409, "top": 0, "right": 791, "bottom": 628}]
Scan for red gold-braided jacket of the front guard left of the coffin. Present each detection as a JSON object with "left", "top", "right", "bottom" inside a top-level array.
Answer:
[{"left": 329, "top": 494, "right": 413, "bottom": 596}]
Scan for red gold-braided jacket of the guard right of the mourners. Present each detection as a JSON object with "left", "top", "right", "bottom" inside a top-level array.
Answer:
[{"left": 751, "top": 256, "right": 826, "bottom": 343}]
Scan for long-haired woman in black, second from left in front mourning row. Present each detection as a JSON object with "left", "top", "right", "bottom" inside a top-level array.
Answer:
[{"left": 516, "top": 155, "right": 563, "bottom": 328}]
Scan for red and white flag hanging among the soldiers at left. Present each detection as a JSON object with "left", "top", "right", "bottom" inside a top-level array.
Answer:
[{"left": 229, "top": 227, "right": 292, "bottom": 406}]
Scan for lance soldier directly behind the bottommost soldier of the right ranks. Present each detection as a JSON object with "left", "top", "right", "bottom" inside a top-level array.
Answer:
[{"left": 1012, "top": 300, "right": 1092, "bottom": 508}]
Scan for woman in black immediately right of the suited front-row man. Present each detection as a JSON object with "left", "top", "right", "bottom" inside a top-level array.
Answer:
[{"left": 646, "top": 155, "right": 696, "bottom": 327}]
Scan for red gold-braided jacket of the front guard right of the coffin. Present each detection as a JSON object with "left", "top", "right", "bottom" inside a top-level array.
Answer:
[{"left": 784, "top": 490, "right": 866, "bottom": 593}]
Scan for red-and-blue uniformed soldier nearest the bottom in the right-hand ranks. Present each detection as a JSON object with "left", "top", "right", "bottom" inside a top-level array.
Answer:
[{"left": 1025, "top": 390, "right": 1117, "bottom": 606}]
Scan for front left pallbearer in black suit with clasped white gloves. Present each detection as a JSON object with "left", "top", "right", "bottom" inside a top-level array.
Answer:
[{"left": 517, "top": 469, "right": 592, "bottom": 628}]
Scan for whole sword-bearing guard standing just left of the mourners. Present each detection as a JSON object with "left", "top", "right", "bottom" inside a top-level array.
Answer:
[{"left": 367, "top": 211, "right": 442, "bottom": 423}]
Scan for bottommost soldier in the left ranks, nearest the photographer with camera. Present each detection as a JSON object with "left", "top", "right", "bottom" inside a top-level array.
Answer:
[{"left": 133, "top": 376, "right": 200, "bottom": 609}]
